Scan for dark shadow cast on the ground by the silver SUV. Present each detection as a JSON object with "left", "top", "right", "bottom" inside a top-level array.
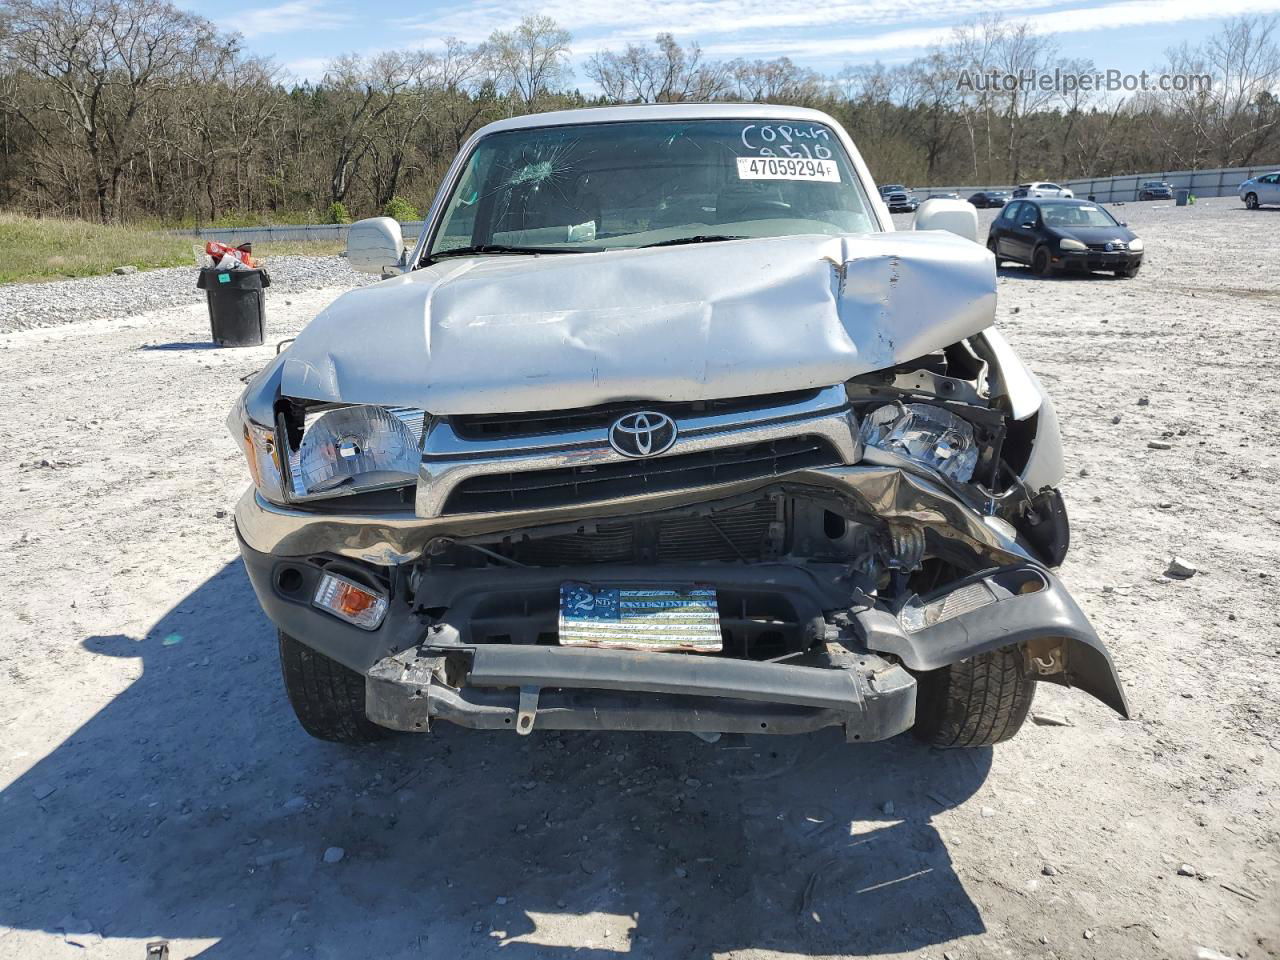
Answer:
[{"left": 0, "top": 562, "right": 991, "bottom": 960}]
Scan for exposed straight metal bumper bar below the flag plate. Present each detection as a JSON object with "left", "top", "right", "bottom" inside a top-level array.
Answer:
[{"left": 365, "top": 644, "right": 915, "bottom": 741}]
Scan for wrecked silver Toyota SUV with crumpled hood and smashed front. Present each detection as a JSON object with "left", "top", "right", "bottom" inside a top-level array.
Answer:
[{"left": 229, "top": 105, "right": 1128, "bottom": 746}]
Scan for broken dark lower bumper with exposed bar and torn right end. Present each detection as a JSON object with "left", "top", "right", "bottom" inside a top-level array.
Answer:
[{"left": 241, "top": 529, "right": 1128, "bottom": 741}]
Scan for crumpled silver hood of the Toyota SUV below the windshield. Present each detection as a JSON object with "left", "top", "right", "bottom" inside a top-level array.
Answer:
[{"left": 280, "top": 232, "right": 996, "bottom": 415}]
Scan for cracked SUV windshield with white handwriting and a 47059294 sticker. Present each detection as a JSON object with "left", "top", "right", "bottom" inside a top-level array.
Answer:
[{"left": 430, "top": 119, "right": 879, "bottom": 256}]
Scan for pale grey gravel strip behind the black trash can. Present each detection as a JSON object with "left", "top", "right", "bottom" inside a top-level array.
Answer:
[{"left": 0, "top": 256, "right": 378, "bottom": 333}]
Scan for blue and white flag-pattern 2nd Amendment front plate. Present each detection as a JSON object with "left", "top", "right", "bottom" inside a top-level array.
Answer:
[{"left": 559, "top": 581, "right": 723, "bottom": 653}]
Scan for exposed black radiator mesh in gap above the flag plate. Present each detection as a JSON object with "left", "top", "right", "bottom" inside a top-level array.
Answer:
[{"left": 508, "top": 499, "right": 781, "bottom": 567}]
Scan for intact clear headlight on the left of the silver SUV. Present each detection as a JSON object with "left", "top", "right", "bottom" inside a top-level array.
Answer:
[{"left": 289, "top": 404, "right": 425, "bottom": 499}]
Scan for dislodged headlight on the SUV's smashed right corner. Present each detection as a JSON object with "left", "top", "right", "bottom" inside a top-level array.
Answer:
[{"left": 859, "top": 403, "right": 978, "bottom": 484}]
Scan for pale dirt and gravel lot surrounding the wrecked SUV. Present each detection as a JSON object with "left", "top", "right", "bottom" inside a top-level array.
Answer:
[{"left": 0, "top": 200, "right": 1280, "bottom": 960}]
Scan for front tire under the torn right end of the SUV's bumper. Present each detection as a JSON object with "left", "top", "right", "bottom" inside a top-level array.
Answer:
[{"left": 913, "top": 646, "right": 1036, "bottom": 748}]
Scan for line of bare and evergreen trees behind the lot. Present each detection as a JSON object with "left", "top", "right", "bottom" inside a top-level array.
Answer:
[{"left": 0, "top": 0, "right": 1280, "bottom": 223}]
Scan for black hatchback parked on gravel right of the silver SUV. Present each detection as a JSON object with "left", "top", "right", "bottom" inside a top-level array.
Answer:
[{"left": 987, "top": 197, "right": 1143, "bottom": 278}]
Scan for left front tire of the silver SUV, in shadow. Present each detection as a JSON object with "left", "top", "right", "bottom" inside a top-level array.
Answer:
[{"left": 280, "top": 630, "right": 392, "bottom": 744}]
